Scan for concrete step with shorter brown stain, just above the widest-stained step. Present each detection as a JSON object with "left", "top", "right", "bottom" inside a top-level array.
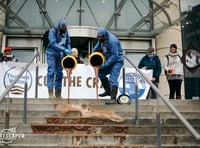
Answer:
[{"left": 0, "top": 116, "right": 200, "bottom": 126}]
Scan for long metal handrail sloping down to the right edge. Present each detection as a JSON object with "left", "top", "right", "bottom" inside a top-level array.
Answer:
[{"left": 124, "top": 55, "right": 200, "bottom": 140}]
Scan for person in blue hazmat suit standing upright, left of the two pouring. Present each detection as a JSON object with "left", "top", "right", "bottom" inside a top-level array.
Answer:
[{"left": 46, "top": 19, "right": 71, "bottom": 98}]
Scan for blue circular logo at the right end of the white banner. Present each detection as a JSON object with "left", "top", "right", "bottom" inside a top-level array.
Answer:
[{"left": 119, "top": 73, "right": 146, "bottom": 99}]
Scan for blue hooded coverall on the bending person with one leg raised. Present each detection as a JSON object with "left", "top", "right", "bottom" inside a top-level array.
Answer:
[{"left": 92, "top": 28, "right": 124, "bottom": 87}]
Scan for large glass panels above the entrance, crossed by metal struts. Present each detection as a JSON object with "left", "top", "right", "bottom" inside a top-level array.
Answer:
[{"left": 6, "top": 0, "right": 152, "bottom": 31}]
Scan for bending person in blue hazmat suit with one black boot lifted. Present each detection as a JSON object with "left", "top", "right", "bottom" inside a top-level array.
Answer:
[{"left": 92, "top": 28, "right": 124, "bottom": 104}]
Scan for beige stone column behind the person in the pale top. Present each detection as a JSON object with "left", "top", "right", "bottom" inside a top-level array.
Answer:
[{"left": 154, "top": 0, "right": 185, "bottom": 98}]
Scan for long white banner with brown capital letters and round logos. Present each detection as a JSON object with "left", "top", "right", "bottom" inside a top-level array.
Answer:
[{"left": 0, "top": 62, "right": 152, "bottom": 99}]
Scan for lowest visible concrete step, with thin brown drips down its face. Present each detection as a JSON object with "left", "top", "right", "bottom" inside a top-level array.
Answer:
[{"left": 0, "top": 133, "right": 200, "bottom": 146}]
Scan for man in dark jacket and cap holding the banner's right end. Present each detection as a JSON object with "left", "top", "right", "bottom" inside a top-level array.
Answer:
[{"left": 138, "top": 47, "right": 162, "bottom": 99}]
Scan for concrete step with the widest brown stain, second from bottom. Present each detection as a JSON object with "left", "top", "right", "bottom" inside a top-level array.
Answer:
[{"left": 1, "top": 124, "right": 200, "bottom": 135}]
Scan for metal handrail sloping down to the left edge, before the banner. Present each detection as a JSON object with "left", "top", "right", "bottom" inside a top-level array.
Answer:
[{"left": 0, "top": 52, "right": 39, "bottom": 104}]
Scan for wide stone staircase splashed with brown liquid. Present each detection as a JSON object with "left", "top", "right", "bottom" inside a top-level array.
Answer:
[{"left": 0, "top": 98, "right": 200, "bottom": 148}]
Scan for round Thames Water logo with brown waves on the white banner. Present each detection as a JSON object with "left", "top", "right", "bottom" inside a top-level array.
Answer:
[{"left": 3, "top": 67, "right": 32, "bottom": 95}]
